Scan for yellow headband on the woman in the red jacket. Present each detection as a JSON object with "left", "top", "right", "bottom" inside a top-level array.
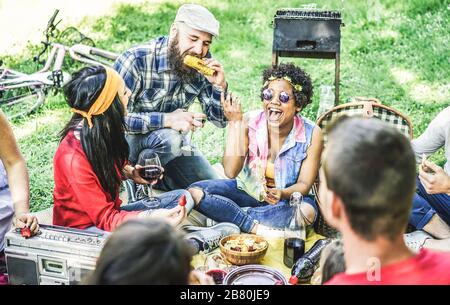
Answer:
[{"left": 72, "top": 67, "right": 123, "bottom": 128}]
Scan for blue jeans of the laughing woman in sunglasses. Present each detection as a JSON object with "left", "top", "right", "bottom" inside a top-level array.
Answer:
[{"left": 190, "top": 179, "right": 317, "bottom": 232}]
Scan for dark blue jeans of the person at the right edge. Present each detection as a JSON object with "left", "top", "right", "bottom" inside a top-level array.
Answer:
[{"left": 409, "top": 178, "right": 450, "bottom": 230}]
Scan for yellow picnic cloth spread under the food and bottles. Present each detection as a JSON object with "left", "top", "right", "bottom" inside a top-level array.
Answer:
[{"left": 191, "top": 230, "right": 325, "bottom": 281}]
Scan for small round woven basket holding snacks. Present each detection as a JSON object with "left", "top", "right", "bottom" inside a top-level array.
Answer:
[{"left": 219, "top": 234, "right": 269, "bottom": 266}]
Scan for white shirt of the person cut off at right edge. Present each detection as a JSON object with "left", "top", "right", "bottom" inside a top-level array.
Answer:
[{"left": 412, "top": 106, "right": 450, "bottom": 175}]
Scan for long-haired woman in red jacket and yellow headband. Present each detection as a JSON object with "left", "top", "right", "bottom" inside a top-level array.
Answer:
[{"left": 53, "top": 66, "right": 193, "bottom": 231}]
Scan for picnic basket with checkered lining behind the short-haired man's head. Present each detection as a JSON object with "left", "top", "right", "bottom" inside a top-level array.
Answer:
[{"left": 312, "top": 97, "right": 413, "bottom": 238}]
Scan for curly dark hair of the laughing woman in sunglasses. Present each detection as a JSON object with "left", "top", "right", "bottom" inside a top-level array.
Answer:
[{"left": 261, "top": 63, "right": 313, "bottom": 109}]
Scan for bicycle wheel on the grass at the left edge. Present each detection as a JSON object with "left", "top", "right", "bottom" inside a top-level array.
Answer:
[{"left": 0, "top": 86, "right": 46, "bottom": 120}]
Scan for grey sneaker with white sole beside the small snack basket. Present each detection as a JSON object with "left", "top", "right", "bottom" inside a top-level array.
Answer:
[{"left": 184, "top": 222, "right": 241, "bottom": 253}]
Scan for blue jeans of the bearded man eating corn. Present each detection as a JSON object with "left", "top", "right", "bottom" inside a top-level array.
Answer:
[{"left": 126, "top": 128, "right": 218, "bottom": 190}]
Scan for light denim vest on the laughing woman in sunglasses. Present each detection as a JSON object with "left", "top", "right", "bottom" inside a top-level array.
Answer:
[{"left": 236, "top": 110, "right": 315, "bottom": 202}]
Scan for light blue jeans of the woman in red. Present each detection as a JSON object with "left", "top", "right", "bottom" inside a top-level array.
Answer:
[{"left": 85, "top": 190, "right": 194, "bottom": 234}]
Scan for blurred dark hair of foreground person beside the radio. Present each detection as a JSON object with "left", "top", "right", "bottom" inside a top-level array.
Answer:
[{"left": 85, "top": 218, "right": 193, "bottom": 285}]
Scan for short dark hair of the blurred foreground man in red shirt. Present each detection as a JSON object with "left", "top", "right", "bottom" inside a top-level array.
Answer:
[{"left": 323, "top": 117, "right": 415, "bottom": 241}]
